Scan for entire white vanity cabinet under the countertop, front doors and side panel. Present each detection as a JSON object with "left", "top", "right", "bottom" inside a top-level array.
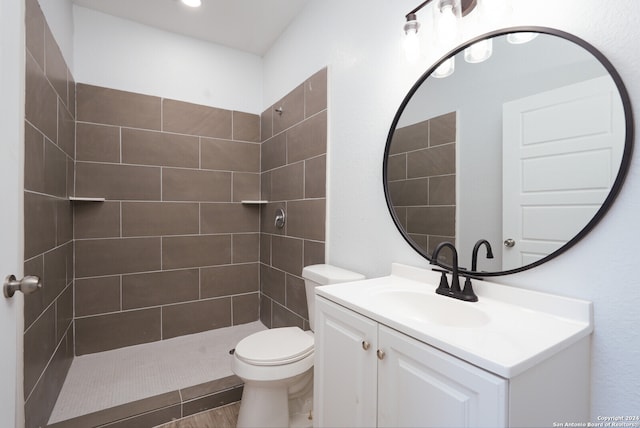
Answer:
[{"left": 314, "top": 288, "right": 590, "bottom": 428}]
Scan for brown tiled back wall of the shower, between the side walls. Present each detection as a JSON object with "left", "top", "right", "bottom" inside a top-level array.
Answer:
[{"left": 74, "top": 84, "right": 260, "bottom": 355}]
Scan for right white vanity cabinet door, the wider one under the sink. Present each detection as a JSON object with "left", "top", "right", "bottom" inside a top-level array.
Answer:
[{"left": 378, "top": 325, "right": 507, "bottom": 427}]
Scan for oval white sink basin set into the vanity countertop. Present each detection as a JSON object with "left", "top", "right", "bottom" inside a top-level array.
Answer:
[{"left": 370, "top": 289, "right": 490, "bottom": 328}]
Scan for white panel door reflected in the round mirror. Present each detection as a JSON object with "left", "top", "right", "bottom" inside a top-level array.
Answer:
[{"left": 502, "top": 76, "right": 625, "bottom": 270}]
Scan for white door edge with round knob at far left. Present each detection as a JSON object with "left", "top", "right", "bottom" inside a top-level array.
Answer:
[{"left": 0, "top": 0, "right": 25, "bottom": 427}]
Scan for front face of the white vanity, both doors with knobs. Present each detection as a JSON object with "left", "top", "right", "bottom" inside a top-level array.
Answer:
[{"left": 314, "top": 298, "right": 507, "bottom": 427}]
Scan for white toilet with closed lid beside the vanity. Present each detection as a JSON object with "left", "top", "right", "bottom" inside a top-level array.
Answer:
[{"left": 232, "top": 265, "right": 364, "bottom": 428}]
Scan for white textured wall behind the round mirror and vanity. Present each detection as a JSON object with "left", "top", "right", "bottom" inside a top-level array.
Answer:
[{"left": 264, "top": 0, "right": 640, "bottom": 422}]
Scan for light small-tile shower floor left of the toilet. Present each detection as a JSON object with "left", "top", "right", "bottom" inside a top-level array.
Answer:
[{"left": 49, "top": 321, "right": 266, "bottom": 424}]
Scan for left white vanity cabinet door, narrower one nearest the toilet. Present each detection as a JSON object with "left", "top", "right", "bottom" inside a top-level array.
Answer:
[{"left": 313, "top": 296, "right": 377, "bottom": 427}]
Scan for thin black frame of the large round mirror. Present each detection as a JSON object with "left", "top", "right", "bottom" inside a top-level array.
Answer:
[{"left": 382, "top": 26, "right": 634, "bottom": 277}]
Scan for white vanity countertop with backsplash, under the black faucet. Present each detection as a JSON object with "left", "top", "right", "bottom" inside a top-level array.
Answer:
[{"left": 315, "top": 264, "right": 593, "bottom": 378}]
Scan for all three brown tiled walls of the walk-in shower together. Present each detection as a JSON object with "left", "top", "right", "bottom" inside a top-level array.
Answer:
[{"left": 25, "top": 0, "right": 327, "bottom": 427}]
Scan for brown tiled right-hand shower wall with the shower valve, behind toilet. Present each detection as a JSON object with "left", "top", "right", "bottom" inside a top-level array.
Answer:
[{"left": 260, "top": 69, "right": 327, "bottom": 329}]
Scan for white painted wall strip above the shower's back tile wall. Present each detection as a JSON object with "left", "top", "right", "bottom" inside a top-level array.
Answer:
[{"left": 74, "top": 6, "right": 262, "bottom": 114}]
